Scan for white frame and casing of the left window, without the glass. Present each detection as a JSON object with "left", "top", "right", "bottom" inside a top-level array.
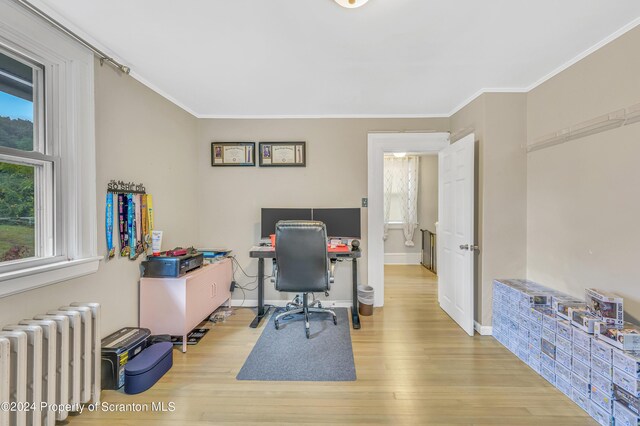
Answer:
[{"left": 0, "top": 2, "right": 101, "bottom": 297}]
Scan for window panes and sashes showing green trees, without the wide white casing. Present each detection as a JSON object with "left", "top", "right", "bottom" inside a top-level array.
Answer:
[{"left": 0, "top": 49, "right": 56, "bottom": 269}]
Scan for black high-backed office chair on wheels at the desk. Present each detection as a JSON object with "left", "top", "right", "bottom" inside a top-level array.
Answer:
[{"left": 273, "top": 220, "right": 338, "bottom": 339}]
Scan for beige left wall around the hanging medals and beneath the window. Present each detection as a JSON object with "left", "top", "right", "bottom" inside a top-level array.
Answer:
[{"left": 0, "top": 63, "right": 198, "bottom": 335}]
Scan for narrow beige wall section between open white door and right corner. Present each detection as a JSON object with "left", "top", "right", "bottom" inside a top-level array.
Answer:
[{"left": 451, "top": 93, "right": 527, "bottom": 326}]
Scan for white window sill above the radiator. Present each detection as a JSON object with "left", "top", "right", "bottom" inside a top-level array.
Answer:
[{"left": 0, "top": 257, "right": 102, "bottom": 297}]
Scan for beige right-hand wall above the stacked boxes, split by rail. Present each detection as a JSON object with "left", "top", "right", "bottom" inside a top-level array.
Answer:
[{"left": 527, "top": 28, "right": 640, "bottom": 320}]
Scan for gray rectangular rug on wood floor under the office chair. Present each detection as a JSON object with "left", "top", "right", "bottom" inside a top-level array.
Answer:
[{"left": 236, "top": 308, "right": 356, "bottom": 382}]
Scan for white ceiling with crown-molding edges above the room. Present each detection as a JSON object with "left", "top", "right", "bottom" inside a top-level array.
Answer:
[{"left": 32, "top": 0, "right": 640, "bottom": 117}]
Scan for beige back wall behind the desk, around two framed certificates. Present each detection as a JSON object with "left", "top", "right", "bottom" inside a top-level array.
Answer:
[{"left": 198, "top": 119, "right": 449, "bottom": 300}]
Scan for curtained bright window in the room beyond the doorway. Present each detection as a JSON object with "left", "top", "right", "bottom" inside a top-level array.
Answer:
[{"left": 384, "top": 155, "right": 420, "bottom": 247}]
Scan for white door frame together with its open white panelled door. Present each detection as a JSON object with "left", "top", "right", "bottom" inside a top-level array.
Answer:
[{"left": 367, "top": 133, "right": 477, "bottom": 336}]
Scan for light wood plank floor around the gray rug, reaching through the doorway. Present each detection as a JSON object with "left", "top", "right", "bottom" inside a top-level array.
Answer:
[{"left": 69, "top": 266, "right": 596, "bottom": 426}]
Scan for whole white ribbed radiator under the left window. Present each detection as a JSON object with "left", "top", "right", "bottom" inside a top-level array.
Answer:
[{"left": 0, "top": 303, "right": 101, "bottom": 426}]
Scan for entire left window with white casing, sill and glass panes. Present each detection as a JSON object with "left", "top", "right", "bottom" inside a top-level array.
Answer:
[{"left": 0, "top": 2, "right": 99, "bottom": 297}]
